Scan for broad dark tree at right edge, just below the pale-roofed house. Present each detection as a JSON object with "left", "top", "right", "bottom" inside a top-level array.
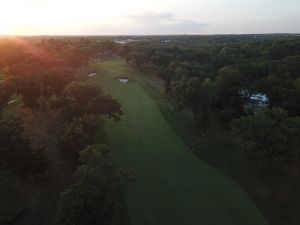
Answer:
[{"left": 233, "top": 108, "right": 300, "bottom": 166}]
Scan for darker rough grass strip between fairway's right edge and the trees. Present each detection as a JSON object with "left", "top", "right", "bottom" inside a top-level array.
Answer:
[{"left": 138, "top": 64, "right": 297, "bottom": 225}]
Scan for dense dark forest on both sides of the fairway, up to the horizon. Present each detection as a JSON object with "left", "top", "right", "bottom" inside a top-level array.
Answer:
[{"left": 0, "top": 35, "right": 300, "bottom": 225}]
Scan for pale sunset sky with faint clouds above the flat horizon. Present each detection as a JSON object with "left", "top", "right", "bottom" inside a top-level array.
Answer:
[{"left": 0, "top": 0, "right": 300, "bottom": 35}]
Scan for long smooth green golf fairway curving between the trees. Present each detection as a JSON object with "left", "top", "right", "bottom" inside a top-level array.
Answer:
[{"left": 90, "top": 61, "right": 267, "bottom": 225}]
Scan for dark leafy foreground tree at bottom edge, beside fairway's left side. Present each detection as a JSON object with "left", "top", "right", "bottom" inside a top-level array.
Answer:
[{"left": 57, "top": 145, "right": 124, "bottom": 225}]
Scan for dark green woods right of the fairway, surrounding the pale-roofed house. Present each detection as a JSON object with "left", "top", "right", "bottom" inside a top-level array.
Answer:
[{"left": 123, "top": 35, "right": 300, "bottom": 170}]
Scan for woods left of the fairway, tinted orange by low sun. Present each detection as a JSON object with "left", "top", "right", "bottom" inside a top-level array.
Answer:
[{"left": 0, "top": 38, "right": 128, "bottom": 225}]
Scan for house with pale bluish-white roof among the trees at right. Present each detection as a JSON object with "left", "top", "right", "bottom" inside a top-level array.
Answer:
[{"left": 241, "top": 90, "right": 269, "bottom": 113}]
